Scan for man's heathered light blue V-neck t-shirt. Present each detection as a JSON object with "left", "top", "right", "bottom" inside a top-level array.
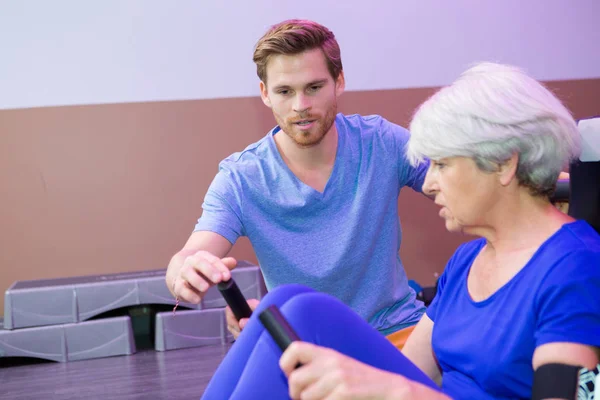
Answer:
[{"left": 195, "top": 114, "right": 428, "bottom": 334}]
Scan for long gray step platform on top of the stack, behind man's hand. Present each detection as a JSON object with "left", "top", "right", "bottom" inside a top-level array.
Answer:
[{"left": 4, "top": 261, "right": 264, "bottom": 329}]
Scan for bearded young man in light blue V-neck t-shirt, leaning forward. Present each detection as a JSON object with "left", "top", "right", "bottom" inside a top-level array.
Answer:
[{"left": 166, "top": 20, "right": 428, "bottom": 347}]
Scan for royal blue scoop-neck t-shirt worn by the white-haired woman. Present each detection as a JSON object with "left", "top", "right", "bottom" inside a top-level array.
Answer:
[{"left": 427, "top": 221, "right": 600, "bottom": 399}]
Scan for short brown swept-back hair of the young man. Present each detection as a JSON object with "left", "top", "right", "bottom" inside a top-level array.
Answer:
[{"left": 253, "top": 19, "right": 342, "bottom": 84}]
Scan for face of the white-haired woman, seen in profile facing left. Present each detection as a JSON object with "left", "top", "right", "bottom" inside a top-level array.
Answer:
[{"left": 423, "top": 157, "right": 502, "bottom": 233}]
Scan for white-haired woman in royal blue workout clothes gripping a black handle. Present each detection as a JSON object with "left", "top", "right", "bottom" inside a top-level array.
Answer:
[{"left": 204, "top": 63, "right": 600, "bottom": 399}]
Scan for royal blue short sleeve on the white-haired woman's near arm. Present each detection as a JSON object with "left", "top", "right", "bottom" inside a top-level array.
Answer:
[{"left": 535, "top": 251, "right": 600, "bottom": 346}]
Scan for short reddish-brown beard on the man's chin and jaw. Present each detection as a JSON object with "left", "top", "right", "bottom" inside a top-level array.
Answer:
[{"left": 275, "top": 103, "right": 337, "bottom": 148}]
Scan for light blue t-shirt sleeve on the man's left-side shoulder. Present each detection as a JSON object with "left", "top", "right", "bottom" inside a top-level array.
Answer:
[{"left": 194, "top": 167, "right": 245, "bottom": 244}]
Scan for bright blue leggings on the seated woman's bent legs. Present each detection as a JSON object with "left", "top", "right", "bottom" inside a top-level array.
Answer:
[{"left": 202, "top": 285, "right": 439, "bottom": 400}]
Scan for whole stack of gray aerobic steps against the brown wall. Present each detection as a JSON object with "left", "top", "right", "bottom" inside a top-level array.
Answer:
[{"left": 0, "top": 261, "right": 266, "bottom": 362}]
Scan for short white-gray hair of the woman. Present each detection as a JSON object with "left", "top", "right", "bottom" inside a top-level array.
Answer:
[{"left": 407, "top": 63, "right": 581, "bottom": 196}]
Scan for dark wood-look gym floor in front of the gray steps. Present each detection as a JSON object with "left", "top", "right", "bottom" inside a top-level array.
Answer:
[{"left": 0, "top": 345, "right": 231, "bottom": 400}]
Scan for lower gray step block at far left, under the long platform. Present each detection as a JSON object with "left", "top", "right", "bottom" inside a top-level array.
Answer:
[{"left": 0, "top": 316, "right": 136, "bottom": 362}]
